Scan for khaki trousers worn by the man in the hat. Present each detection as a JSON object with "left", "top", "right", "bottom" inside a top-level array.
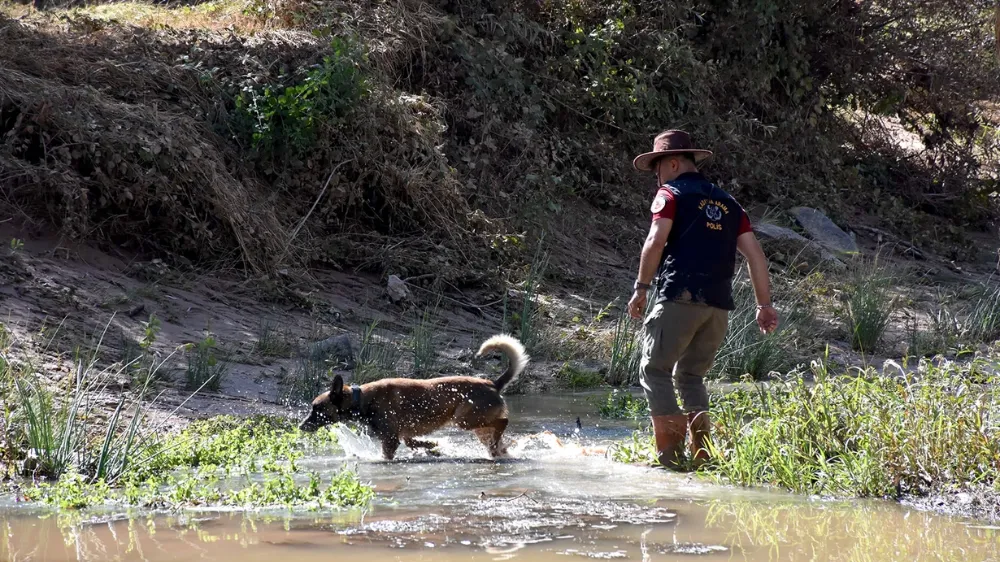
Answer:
[{"left": 639, "top": 302, "right": 729, "bottom": 416}]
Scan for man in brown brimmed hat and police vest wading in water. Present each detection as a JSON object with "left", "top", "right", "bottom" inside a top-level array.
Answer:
[{"left": 628, "top": 131, "right": 778, "bottom": 470}]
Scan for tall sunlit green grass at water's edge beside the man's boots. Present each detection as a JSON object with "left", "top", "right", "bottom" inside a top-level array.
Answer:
[{"left": 615, "top": 352, "right": 1000, "bottom": 497}]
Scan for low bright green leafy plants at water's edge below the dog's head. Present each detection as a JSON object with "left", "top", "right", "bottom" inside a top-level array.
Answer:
[{"left": 26, "top": 416, "right": 374, "bottom": 509}]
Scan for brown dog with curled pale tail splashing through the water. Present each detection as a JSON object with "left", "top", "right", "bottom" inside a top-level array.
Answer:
[{"left": 299, "top": 335, "right": 529, "bottom": 459}]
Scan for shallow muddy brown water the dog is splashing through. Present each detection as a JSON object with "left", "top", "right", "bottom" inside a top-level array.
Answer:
[{"left": 0, "top": 395, "right": 1000, "bottom": 562}]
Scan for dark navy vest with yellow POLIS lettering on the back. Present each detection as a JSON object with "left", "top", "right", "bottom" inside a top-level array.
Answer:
[{"left": 656, "top": 173, "right": 743, "bottom": 310}]
